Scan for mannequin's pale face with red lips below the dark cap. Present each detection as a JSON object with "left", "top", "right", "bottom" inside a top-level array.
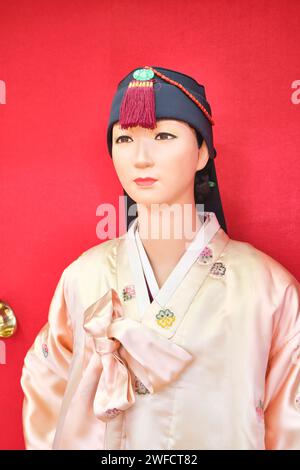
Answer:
[{"left": 112, "top": 119, "right": 209, "bottom": 205}]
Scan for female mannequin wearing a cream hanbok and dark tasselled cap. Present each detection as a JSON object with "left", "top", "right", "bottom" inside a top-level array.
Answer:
[{"left": 21, "top": 67, "right": 300, "bottom": 450}]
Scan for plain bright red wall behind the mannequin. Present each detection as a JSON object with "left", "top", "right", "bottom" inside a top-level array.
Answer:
[{"left": 0, "top": 0, "right": 300, "bottom": 449}]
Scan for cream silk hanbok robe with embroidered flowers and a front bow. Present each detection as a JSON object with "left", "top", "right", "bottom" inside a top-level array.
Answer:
[{"left": 21, "top": 212, "right": 300, "bottom": 450}]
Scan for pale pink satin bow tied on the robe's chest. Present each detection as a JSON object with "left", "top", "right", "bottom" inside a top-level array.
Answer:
[{"left": 84, "top": 289, "right": 193, "bottom": 421}]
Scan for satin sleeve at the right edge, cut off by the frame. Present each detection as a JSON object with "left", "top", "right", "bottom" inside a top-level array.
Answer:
[{"left": 264, "top": 281, "right": 300, "bottom": 450}]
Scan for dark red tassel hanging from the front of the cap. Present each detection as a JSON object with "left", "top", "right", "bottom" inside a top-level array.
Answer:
[{"left": 119, "top": 80, "right": 156, "bottom": 129}]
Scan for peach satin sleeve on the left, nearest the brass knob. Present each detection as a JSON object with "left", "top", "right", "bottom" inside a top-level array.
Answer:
[{"left": 21, "top": 271, "right": 73, "bottom": 450}]
